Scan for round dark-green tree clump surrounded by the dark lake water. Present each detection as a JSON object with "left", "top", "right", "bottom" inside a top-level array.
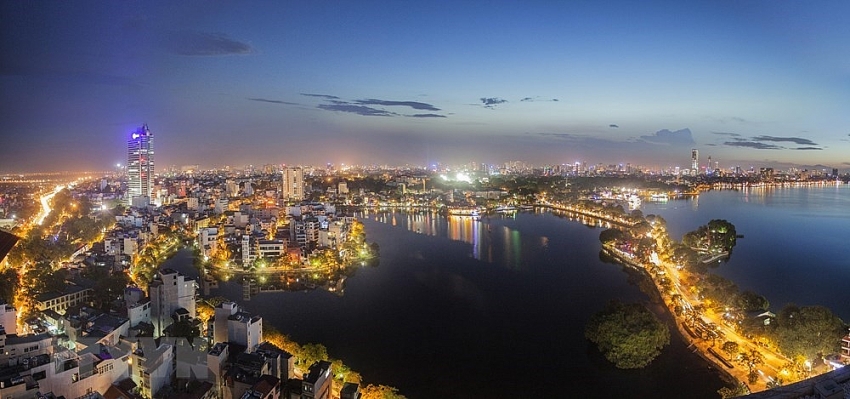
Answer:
[{"left": 584, "top": 300, "right": 670, "bottom": 369}]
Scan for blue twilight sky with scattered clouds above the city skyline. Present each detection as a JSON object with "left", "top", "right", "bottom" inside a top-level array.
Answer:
[{"left": 0, "top": 0, "right": 850, "bottom": 174}]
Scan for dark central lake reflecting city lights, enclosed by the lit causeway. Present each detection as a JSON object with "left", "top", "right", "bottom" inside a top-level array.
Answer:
[{"left": 189, "top": 213, "right": 724, "bottom": 398}]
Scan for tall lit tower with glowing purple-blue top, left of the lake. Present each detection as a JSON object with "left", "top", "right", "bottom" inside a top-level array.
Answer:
[{"left": 127, "top": 124, "right": 154, "bottom": 203}]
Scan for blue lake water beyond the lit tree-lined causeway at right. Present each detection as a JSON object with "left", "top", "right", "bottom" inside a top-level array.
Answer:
[{"left": 641, "top": 184, "right": 850, "bottom": 322}]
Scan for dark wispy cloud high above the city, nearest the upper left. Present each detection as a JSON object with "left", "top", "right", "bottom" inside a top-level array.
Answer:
[{"left": 164, "top": 31, "right": 254, "bottom": 56}]
